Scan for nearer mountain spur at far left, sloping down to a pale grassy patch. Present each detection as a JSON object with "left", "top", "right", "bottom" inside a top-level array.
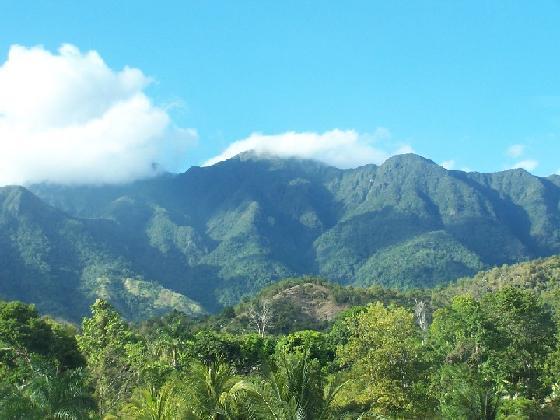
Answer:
[{"left": 0, "top": 187, "right": 204, "bottom": 321}]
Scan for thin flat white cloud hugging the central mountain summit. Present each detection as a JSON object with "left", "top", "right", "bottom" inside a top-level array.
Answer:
[{"left": 204, "top": 128, "right": 412, "bottom": 168}]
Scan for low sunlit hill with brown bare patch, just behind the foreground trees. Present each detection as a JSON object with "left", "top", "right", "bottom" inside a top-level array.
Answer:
[{"left": 207, "top": 256, "right": 560, "bottom": 334}]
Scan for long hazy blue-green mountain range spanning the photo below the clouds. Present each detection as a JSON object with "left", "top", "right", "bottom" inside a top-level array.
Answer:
[{"left": 0, "top": 153, "right": 560, "bottom": 320}]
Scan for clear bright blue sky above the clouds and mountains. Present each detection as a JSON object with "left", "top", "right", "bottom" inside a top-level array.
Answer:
[{"left": 0, "top": 0, "right": 560, "bottom": 183}]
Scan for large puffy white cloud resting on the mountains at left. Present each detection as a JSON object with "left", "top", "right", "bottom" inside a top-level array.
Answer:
[{"left": 0, "top": 45, "right": 196, "bottom": 185}]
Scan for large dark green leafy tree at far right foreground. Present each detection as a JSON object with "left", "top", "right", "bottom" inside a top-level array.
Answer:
[{"left": 430, "top": 287, "right": 556, "bottom": 419}]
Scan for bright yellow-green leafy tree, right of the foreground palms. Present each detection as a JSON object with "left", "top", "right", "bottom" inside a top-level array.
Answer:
[{"left": 338, "top": 303, "right": 429, "bottom": 417}]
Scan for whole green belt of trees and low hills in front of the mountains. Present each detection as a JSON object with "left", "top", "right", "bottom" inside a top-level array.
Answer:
[{"left": 0, "top": 253, "right": 560, "bottom": 419}]
